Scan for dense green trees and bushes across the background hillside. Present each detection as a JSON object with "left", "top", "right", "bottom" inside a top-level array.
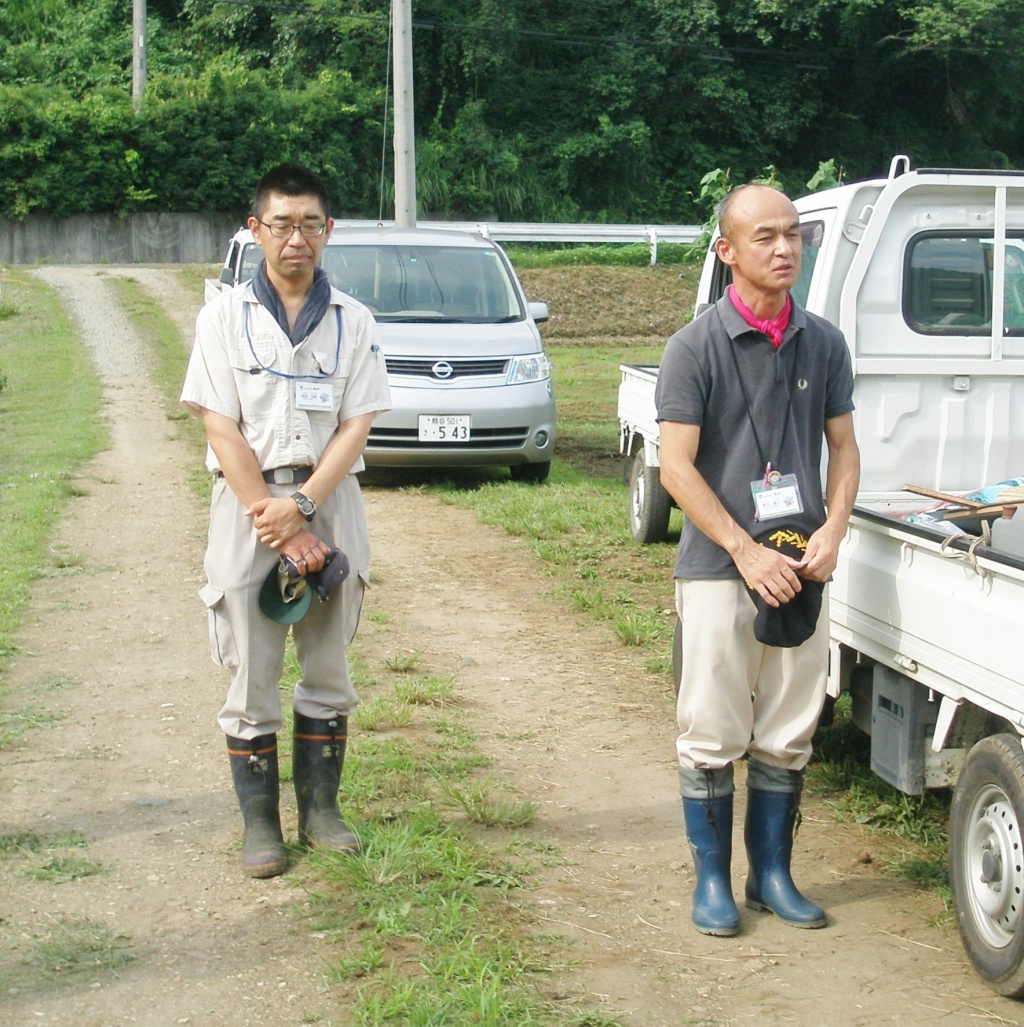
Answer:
[{"left": 0, "top": 0, "right": 1024, "bottom": 223}]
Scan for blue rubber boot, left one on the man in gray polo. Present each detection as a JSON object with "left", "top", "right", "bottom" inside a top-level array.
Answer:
[{"left": 680, "top": 767, "right": 739, "bottom": 938}]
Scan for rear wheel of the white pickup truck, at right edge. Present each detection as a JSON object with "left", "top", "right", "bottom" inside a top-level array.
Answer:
[{"left": 949, "top": 734, "right": 1024, "bottom": 998}]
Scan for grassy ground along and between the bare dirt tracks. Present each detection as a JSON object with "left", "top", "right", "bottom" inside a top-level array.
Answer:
[{"left": 0, "top": 251, "right": 945, "bottom": 1027}]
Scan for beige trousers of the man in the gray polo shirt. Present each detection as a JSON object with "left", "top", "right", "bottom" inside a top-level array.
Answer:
[{"left": 676, "top": 580, "right": 829, "bottom": 770}]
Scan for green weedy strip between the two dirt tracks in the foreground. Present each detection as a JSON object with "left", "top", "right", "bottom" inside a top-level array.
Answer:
[{"left": 273, "top": 620, "right": 614, "bottom": 1027}]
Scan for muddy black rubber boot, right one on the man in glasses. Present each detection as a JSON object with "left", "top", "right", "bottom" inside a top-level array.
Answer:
[{"left": 292, "top": 713, "right": 359, "bottom": 852}]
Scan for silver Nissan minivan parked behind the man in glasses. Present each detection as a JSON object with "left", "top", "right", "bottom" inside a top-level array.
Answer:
[{"left": 210, "top": 228, "right": 556, "bottom": 482}]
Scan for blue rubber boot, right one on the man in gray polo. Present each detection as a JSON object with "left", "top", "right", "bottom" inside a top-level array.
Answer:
[{"left": 744, "top": 760, "right": 827, "bottom": 927}]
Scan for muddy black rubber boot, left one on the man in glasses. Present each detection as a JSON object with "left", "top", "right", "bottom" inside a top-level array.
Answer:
[{"left": 228, "top": 734, "right": 288, "bottom": 877}]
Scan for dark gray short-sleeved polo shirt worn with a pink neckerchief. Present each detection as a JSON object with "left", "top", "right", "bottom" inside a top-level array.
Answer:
[{"left": 654, "top": 295, "right": 854, "bottom": 579}]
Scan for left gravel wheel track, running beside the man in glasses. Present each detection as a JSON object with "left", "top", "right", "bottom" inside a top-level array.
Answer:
[{"left": 0, "top": 267, "right": 336, "bottom": 1027}]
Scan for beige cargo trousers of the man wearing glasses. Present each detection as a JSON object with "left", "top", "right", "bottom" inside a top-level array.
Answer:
[{"left": 199, "top": 474, "right": 370, "bottom": 739}]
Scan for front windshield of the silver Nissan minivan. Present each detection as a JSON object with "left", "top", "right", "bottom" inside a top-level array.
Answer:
[{"left": 321, "top": 243, "right": 524, "bottom": 324}]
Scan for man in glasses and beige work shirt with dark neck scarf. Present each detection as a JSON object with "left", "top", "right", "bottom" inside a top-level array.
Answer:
[{"left": 181, "top": 163, "right": 391, "bottom": 877}]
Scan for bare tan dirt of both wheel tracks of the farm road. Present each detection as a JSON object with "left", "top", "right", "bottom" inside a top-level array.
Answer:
[{"left": 0, "top": 268, "right": 1024, "bottom": 1027}]
